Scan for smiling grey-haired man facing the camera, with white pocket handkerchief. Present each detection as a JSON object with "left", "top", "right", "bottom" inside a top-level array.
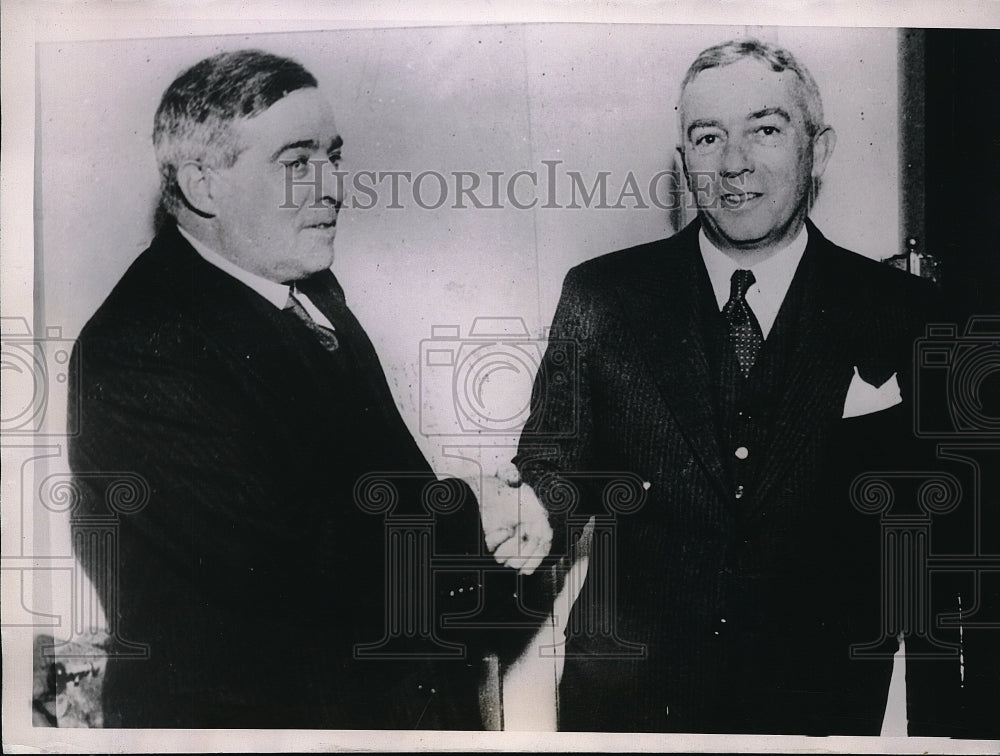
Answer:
[{"left": 515, "top": 40, "right": 948, "bottom": 734}]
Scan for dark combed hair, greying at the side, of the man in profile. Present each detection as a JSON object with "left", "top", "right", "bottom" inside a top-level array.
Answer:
[{"left": 153, "top": 50, "right": 317, "bottom": 217}]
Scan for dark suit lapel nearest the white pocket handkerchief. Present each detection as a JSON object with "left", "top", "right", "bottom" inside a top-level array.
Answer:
[{"left": 750, "top": 221, "right": 859, "bottom": 508}]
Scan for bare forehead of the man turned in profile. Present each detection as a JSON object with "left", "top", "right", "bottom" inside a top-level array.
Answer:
[{"left": 234, "top": 87, "right": 337, "bottom": 151}]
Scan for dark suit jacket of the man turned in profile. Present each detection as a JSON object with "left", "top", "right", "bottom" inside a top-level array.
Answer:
[{"left": 70, "top": 227, "right": 481, "bottom": 729}]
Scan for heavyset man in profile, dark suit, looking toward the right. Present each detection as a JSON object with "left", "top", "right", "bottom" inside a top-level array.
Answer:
[{"left": 70, "top": 50, "right": 481, "bottom": 729}]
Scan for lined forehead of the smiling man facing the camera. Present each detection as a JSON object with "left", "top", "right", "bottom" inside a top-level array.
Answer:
[{"left": 681, "top": 58, "right": 805, "bottom": 125}]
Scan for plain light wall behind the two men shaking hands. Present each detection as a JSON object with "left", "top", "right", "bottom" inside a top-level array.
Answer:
[{"left": 28, "top": 24, "right": 904, "bottom": 728}]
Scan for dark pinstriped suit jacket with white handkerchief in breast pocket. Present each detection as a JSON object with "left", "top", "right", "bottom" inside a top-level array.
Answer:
[{"left": 516, "top": 222, "right": 934, "bottom": 734}]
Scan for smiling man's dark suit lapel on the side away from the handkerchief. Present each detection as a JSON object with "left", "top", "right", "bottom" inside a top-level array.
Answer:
[{"left": 619, "top": 223, "right": 730, "bottom": 497}]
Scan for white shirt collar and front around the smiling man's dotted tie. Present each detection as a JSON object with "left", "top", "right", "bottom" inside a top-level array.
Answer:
[{"left": 698, "top": 225, "right": 809, "bottom": 339}]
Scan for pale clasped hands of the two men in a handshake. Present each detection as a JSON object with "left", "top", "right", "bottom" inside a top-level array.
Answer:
[{"left": 479, "top": 464, "right": 552, "bottom": 575}]
